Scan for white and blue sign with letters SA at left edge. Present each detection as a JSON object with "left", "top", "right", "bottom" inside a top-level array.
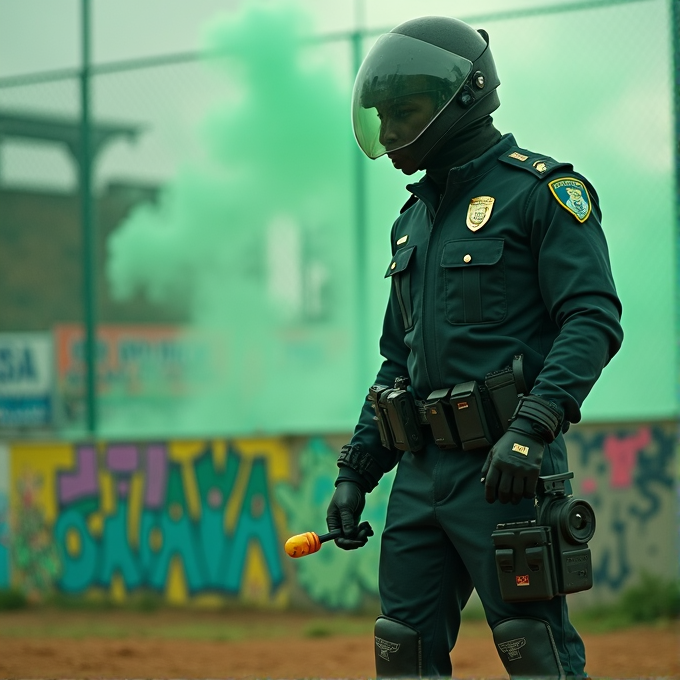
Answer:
[{"left": 0, "top": 333, "right": 54, "bottom": 426}]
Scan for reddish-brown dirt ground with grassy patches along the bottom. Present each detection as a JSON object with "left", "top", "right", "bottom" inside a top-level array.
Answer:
[{"left": 0, "top": 611, "right": 680, "bottom": 678}]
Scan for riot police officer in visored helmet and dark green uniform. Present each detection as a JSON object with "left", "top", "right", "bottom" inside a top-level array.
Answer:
[{"left": 327, "top": 17, "right": 623, "bottom": 677}]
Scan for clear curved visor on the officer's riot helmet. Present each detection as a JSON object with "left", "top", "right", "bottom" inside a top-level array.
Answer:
[{"left": 352, "top": 33, "right": 472, "bottom": 158}]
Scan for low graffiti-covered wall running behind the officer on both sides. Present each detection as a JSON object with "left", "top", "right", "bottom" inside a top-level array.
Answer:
[{"left": 0, "top": 423, "right": 678, "bottom": 609}]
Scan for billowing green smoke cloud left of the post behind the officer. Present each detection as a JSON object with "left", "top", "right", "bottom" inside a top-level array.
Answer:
[{"left": 107, "top": 3, "right": 372, "bottom": 434}]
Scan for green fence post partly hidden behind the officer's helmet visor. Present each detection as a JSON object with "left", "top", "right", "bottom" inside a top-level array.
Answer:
[{"left": 352, "top": 0, "right": 372, "bottom": 390}]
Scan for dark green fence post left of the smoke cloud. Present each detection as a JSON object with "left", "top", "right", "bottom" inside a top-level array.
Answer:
[{"left": 80, "top": 0, "right": 97, "bottom": 436}]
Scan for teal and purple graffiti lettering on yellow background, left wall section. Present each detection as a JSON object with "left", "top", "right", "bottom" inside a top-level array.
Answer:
[{"left": 11, "top": 439, "right": 289, "bottom": 606}]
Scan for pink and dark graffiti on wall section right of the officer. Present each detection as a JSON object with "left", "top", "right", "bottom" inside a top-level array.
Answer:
[{"left": 567, "top": 424, "right": 678, "bottom": 599}]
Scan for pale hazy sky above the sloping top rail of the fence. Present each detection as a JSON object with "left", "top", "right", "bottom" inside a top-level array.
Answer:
[{"left": 0, "top": 0, "right": 584, "bottom": 77}]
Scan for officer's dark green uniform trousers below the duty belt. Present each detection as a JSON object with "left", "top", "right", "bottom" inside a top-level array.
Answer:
[{"left": 379, "top": 436, "right": 585, "bottom": 677}]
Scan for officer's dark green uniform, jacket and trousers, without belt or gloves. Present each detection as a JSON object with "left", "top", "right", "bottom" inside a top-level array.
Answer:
[{"left": 339, "top": 135, "right": 622, "bottom": 675}]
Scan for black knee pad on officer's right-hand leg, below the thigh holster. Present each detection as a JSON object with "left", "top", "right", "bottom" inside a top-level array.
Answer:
[{"left": 493, "top": 618, "right": 566, "bottom": 678}]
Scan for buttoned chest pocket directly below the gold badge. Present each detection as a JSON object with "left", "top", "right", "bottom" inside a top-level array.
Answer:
[{"left": 441, "top": 238, "right": 507, "bottom": 324}]
